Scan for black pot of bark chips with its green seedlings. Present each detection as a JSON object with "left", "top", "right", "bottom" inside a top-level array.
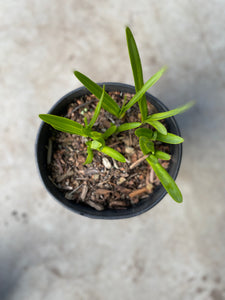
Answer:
[{"left": 36, "top": 27, "right": 193, "bottom": 219}]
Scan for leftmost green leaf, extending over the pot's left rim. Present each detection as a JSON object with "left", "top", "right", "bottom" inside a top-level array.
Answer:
[{"left": 39, "top": 114, "right": 87, "bottom": 136}]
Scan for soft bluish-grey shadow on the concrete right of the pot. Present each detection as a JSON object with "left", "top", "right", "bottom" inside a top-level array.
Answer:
[{"left": 150, "top": 70, "right": 225, "bottom": 155}]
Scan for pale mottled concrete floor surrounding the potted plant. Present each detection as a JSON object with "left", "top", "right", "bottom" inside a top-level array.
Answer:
[{"left": 0, "top": 0, "right": 225, "bottom": 300}]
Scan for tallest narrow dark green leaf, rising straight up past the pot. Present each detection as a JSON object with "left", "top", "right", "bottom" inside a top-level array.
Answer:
[{"left": 126, "top": 27, "right": 148, "bottom": 122}]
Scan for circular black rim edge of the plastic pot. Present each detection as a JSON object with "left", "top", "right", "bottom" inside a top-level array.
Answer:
[{"left": 35, "top": 82, "right": 182, "bottom": 220}]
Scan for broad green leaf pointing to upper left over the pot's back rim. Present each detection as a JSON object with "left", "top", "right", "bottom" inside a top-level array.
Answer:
[{"left": 74, "top": 71, "right": 120, "bottom": 117}]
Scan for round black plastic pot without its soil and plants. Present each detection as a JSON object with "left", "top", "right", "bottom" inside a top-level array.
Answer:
[{"left": 36, "top": 83, "right": 182, "bottom": 219}]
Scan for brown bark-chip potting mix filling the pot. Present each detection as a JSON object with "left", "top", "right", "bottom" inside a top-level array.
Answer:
[{"left": 48, "top": 92, "right": 170, "bottom": 210}]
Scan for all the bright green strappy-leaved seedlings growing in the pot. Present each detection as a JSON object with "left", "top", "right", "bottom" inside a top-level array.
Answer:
[{"left": 39, "top": 27, "right": 194, "bottom": 202}]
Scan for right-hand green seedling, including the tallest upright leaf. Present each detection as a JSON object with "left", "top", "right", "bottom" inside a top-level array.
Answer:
[{"left": 126, "top": 27, "right": 194, "bottom": 202}]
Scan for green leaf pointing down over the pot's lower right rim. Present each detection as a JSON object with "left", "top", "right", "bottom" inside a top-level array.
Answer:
[{"left": 147, "top": 155, "right": 183, "bottom": 203}]
